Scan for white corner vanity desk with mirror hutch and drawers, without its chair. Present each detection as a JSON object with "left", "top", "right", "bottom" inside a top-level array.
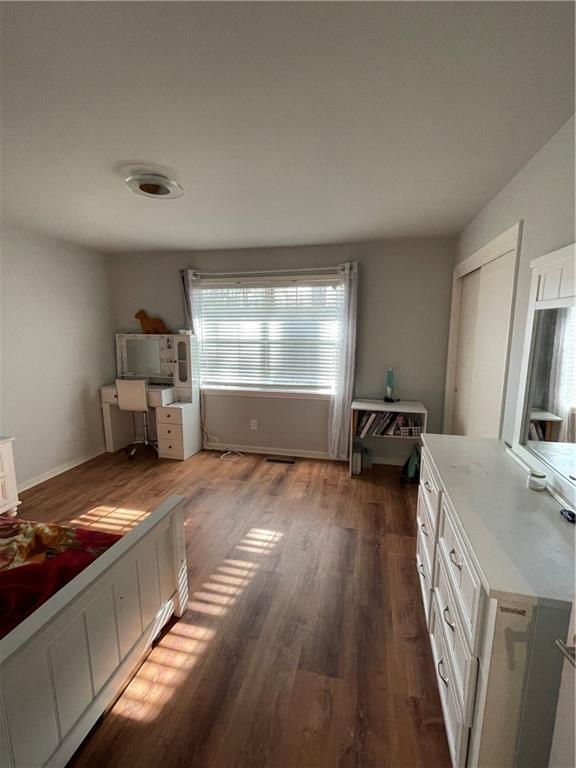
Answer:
[{"left": 100, "top": 333, "right": 202, "bottom": 460}]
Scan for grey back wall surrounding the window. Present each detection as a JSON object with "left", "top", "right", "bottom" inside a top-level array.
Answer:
[{"left": 111, "top": 238, "right": 455, "bottom": 461}]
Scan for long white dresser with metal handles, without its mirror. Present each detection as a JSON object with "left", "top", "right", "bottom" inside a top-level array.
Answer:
[{"left": 416, "top": 434, "right": 574, "bottom": 768}]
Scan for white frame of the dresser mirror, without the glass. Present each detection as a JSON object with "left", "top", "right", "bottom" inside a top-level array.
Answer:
[{"left": 512, "top": 243, "right": 576, "bottom": 509}]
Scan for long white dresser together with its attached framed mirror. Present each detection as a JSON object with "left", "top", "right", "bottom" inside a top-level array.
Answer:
[{"left": 416, "top": 245, "right": 576, "bottom": 768}]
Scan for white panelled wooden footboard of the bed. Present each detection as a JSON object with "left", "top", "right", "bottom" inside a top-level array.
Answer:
[{"left": 0, "top": 496, "right": 188, "bottom": 768}]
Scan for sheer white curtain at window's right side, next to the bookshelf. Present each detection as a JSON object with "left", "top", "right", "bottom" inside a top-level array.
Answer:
[{"left": 328, "top": 262, "right": 358, "bottom": 461}]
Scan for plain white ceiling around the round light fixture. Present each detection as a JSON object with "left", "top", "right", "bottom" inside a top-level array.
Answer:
[{"left": 1, "top": 2, "right": 574, "bottom": 251}]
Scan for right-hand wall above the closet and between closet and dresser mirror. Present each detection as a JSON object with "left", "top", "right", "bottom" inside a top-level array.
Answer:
[{"left": 457, "top": 117, "right": 575, "bottom": 442}]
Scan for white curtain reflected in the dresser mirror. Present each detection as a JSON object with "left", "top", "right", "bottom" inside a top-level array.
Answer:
[{"left": 548, "top": 307, "right": 576, "bottom": 442}]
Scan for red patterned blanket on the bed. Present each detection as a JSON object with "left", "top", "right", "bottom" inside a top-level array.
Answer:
[{"left": 0, "top": 516, "right": 121, "bottom": 637}]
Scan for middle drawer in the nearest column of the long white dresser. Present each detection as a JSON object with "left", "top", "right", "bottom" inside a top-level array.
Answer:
[{"left": 433, "top": 551, "right": 478, "bottom": 725}]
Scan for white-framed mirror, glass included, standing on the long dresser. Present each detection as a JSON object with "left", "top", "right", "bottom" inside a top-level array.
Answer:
[{"left": 514, "top": 245, "right": 576, "bottom": 503}]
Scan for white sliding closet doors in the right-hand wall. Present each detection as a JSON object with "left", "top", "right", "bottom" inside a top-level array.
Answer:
[{"left": 453, "top": 251, "right": 515, "bottom": 437}]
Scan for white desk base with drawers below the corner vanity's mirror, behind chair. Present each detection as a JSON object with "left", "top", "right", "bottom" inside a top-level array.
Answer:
[{"left": 100, "top": 384, "right": 202, "bottom": 460}]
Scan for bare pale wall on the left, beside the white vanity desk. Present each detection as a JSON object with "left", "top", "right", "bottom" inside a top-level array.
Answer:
[{"left": 0, "top": 227, "right": 114, "bottom": 484}]
